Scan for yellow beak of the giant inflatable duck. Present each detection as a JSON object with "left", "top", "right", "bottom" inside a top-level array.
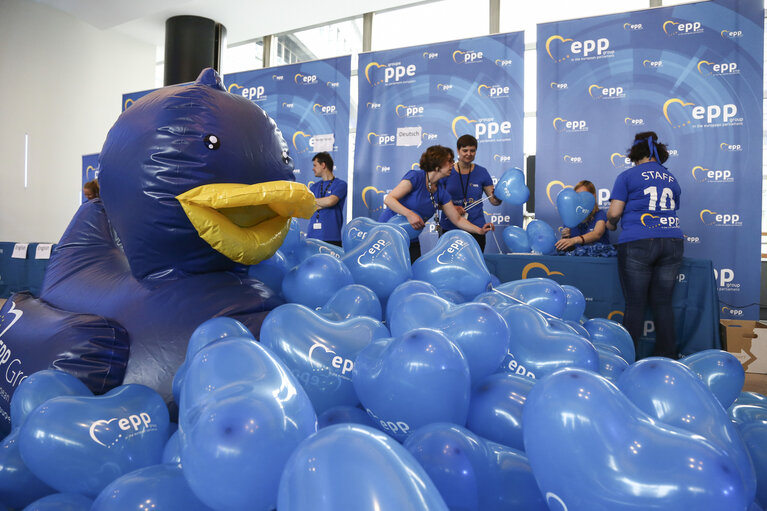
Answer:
[{"left": 176, "top": 181, "right": 317, "bottom": 264}]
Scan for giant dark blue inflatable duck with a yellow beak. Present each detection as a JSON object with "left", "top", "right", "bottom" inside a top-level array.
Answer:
[{"left": 0, "top": 69, "right": 315, "bottom": 428}]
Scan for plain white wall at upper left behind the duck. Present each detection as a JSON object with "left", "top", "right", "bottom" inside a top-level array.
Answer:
[{"left": 0, "top": 0, "right": 155, "bottom": 242}]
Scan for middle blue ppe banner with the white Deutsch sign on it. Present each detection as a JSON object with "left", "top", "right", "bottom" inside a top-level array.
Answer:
[{"left": 352, "top": 32, "right": 524, "bottom": 253}]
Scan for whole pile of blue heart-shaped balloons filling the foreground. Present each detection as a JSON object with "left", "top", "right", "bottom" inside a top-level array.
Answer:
[{"left": 0, "top": 219, "right": 767, "bottom": 511}]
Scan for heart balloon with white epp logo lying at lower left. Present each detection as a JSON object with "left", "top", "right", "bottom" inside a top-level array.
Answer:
[{"left": 19, "top": 384, "right": 170, "bottom": 497}]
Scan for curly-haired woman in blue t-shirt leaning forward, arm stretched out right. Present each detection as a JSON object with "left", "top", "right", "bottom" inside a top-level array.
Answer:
[{"left": 378, "top": 145, "right": 494, "bottom": 262}]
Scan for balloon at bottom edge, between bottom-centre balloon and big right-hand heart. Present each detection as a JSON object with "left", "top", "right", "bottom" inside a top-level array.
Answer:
[{"left": 403, "top": 423, "right": 548, "bottom": 511}]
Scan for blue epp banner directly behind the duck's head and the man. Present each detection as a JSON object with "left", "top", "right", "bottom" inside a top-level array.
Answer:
[{"left": 224, "top": 55, "right": 351, "bottom": 232}]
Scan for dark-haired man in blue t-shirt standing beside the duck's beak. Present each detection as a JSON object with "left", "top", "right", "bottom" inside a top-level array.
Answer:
[{"left": 306, "top": 152, "right": 346, "bottom": 247}]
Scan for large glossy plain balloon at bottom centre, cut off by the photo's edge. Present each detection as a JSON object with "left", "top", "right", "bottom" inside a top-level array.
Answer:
[{"left": 280, "top": 424, "right": 448, "bottom": 511}]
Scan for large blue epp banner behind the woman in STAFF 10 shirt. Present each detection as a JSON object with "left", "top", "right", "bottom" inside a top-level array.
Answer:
[{"left": 535, "top": 0, "right": 764, "bottom": 319}]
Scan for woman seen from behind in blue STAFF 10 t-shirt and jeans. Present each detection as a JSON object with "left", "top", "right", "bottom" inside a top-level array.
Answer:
[{"left": 607, "top": 131, "right": 684, "bottom": 358}]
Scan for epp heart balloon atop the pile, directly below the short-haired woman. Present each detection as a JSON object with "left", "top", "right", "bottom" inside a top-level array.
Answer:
[{"left": 413, "top": 229, "right": 490, "bottom": 301}]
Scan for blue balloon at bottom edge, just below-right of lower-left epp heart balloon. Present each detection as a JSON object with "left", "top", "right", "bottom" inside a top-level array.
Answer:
[{"left": 91, "top": 465, "right": 213, "bottom": 511}]
